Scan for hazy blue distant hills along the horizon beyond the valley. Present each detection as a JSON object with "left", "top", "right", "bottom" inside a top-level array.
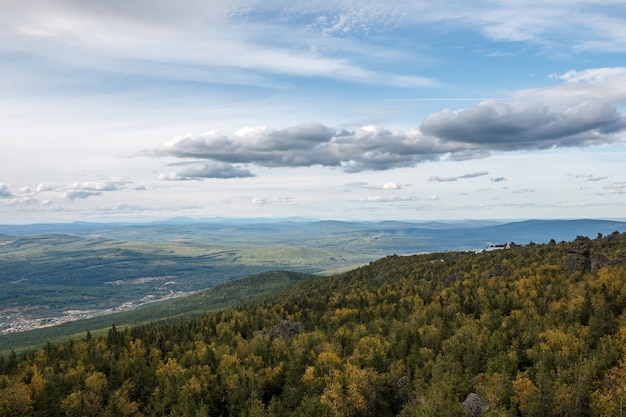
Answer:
[{"left": 0, "top": 218, "right": 626, "bottom": 254}]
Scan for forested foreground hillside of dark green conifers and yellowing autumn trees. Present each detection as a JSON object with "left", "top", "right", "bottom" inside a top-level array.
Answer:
[{"left": 0, "top": 232, "right": 626, "bottom": 417}]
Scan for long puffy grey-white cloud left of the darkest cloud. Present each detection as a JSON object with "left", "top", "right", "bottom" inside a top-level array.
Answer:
[{"left": 155, "top": 122, "right": 448, "bottom": 172}]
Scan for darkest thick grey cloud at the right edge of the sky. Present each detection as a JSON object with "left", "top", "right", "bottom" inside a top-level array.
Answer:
[{"left": 420, "top": 100, "right": 626, "bottom": 151}]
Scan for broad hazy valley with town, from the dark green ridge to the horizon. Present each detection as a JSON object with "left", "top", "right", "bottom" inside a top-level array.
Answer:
[{"left": 0, "top": 220, "right": 626, "bottom": 335}]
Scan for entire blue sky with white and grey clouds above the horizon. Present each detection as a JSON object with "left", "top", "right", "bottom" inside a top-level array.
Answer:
[{"left": 0, "top": 0, "right": 626, "bottom": 224}]
